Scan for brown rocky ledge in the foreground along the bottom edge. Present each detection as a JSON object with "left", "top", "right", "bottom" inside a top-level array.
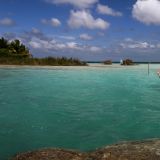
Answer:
[{"left": 11, "top": 139, "right": 160, "bottom": 160}]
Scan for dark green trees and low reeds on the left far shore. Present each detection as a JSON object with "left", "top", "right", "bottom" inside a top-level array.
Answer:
[{"left": 0, "top": 37, "right": 86, "bottom": 66}]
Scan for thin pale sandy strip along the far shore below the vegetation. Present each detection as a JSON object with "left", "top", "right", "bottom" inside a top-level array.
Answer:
[{"left": 0, "top": 63, "right": 160, "bottom": 73}]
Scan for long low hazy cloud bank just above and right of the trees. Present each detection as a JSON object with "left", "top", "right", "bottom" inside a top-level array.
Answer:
[{"left": 2, "top": 28, "right": 104, "bottom": 56}]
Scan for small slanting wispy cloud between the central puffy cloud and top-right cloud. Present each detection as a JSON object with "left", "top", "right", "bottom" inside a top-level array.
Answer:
[{"left": 97, "top": 4, "right": 122, "bottom": 16}]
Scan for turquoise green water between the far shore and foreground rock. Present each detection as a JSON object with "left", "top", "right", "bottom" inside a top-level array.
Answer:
[{"left": 0, "top": 65, "right": 160, "bottom": 160}]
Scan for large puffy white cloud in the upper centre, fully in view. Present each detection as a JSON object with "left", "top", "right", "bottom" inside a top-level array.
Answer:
[{"left": 68, "top": 10, "right": 110, "bottom": 30}]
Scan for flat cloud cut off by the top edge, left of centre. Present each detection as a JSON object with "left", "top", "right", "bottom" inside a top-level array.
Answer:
[{"left": 45, "top": 0, "right": 98, "bottom": 8}]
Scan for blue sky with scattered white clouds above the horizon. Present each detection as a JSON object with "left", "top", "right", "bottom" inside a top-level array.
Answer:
[{"left": 0, "top": 0, "right": 160, "bottom": 61}]
